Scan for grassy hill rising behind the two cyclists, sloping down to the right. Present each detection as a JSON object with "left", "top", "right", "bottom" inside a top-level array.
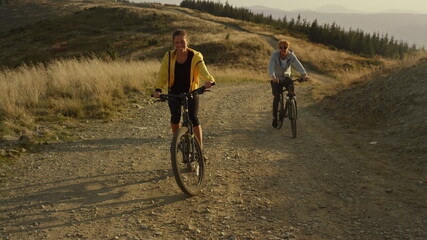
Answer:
[{"left": 0, "top": 1, "right": 380, "bottom": 72}]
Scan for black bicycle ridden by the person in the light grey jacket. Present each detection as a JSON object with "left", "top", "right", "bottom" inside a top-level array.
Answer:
[{"left": 277, "top": 78, "right": 304, "bottom": 138}]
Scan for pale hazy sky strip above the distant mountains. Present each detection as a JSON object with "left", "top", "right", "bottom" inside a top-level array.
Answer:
[{"left": 132, "top": 0, "right": 427, "bottom": 14}]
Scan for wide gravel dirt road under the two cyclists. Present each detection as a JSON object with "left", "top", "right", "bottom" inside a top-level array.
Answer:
[{"left": 0, "top": 83, "right": 427, "bottom": 240}]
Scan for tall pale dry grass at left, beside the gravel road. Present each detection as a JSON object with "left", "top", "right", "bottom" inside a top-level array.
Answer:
[{"left": 0, "top": 58, "right": 159, "bottom": 133}]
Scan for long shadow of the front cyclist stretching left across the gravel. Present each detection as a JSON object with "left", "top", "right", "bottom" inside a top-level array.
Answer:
[{"left": 0, "top": 169, "right": 187, "bottom": 234}]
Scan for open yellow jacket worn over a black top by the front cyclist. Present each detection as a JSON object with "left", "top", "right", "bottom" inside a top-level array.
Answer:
[{"left": 155, "top": 48, "right": 215, "bottom": 91}]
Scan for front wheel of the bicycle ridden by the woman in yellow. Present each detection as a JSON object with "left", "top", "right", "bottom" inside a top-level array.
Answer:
[{"left": 171, "top": 127, "right": 205, "bottom": 196}]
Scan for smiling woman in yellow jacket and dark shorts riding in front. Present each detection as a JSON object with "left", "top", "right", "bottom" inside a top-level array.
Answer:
[{"left": 153, "top": 30, "right": 215, "bottom": 147}]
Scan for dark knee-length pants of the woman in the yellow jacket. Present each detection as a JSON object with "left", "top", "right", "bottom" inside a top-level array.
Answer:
[{"left": 168, "top": 95, "right": 200, "bottom": 127}]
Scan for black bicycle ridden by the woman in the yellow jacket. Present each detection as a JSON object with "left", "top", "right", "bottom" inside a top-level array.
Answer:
[{"left": 153, "top": 83, "right": 215, "bottom": 196}]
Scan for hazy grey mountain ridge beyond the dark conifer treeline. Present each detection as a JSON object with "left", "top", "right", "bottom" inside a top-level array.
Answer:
[{"left": 247, "top": 6, "right": 427, "bottom": 47}]
